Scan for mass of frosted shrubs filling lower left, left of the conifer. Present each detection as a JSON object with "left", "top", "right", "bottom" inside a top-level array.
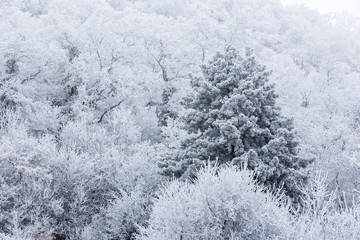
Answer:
[{"left": 0, "top": 110, "right": 161, "bottom": 239}]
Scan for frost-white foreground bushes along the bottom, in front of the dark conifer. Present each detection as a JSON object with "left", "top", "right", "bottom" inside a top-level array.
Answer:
[{"left": 139, "top": 167, "right": 360, "bottom": 240}]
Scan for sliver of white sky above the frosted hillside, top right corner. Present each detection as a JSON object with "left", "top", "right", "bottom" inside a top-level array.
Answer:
[{"left": 281, "top": 0, "right": 360, "bottom": 17}]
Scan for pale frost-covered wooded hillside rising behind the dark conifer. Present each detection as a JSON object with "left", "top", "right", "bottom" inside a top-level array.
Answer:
[{"left": 0, "top": 0, "right": 360, "bottom": 197}]
